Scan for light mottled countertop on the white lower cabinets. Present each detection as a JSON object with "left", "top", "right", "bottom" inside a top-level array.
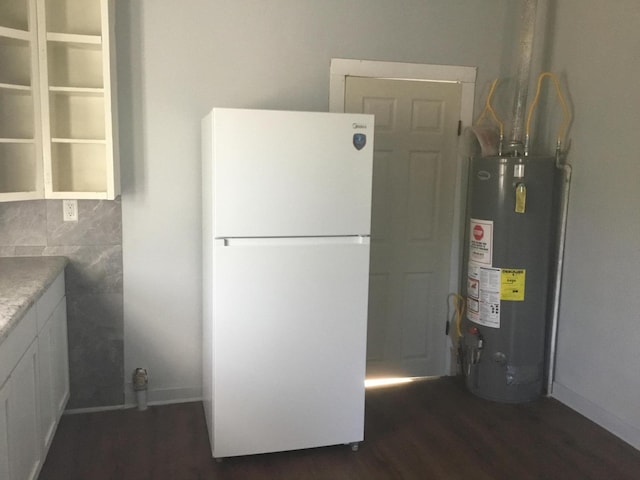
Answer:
[{"left": 0, "top": 257, "right": 67, "bottom": 343}]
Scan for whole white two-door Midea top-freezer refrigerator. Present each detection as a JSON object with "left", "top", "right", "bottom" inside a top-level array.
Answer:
[{"left": 202, "top": 108, "right": 374, "bottom": 458}]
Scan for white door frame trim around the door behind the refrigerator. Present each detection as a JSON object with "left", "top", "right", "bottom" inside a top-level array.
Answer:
[{"left": 329, "top": 58, "right": 478, "bottom": 375}]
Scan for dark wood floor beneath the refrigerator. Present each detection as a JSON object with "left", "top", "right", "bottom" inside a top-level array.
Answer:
[{"left": 40, "top": 378, "right": 640, "bottom": 480}]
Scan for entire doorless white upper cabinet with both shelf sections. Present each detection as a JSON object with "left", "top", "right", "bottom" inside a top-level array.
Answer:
[{"left": 0, "top": 0, "right": 120, "bottom": 200}]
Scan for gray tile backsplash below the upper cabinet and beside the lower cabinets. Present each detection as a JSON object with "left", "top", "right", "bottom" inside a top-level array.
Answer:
[{"left": 0, "top": 199, "right": 124, "bottom": 408}]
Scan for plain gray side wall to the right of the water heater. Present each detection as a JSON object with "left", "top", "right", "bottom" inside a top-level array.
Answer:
[{"left": 551, "top": 0, "right": 640, "bottom": 448}]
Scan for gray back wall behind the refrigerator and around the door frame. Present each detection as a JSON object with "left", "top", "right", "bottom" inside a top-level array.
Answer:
[{"left": 117, "top": 0, "right": 517, "bottom": 401}]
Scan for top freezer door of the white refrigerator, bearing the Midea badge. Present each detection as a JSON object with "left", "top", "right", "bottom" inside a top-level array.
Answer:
[{"left": 210, "top": 109, "right": 374, "bottom": 238}]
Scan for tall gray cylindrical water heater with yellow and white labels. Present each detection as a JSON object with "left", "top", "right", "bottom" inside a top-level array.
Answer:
[{"left": 462, "top": 155, "right": 557, "bottom": 403}]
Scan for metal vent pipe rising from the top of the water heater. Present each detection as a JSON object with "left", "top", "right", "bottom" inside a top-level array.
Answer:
[{"left": 511, "top": 0, "right": 538, "bottom": 150}]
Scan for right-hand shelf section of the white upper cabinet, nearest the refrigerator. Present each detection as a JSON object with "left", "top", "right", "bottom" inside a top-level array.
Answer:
[{"left": 37, "top": 0, "right": 120, "bottom": 200}]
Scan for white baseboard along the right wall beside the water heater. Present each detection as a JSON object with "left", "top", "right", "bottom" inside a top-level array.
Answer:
[{"left": 551, "top": 382, "right": 640, "bottom": 450}]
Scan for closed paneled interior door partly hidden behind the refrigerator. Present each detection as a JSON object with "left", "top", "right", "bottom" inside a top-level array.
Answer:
[{"left": 345, "top": 77, "right": 462, "bottom": 378}]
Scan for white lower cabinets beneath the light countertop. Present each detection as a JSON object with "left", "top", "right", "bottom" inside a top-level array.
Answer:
[{"left": 0, "top": 273, "right": 69, "bottom": 480}]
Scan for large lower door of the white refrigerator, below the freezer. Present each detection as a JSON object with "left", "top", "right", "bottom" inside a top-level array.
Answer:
[{"left": 210, "top": 243, "right": 369, "bottom": 458}]
